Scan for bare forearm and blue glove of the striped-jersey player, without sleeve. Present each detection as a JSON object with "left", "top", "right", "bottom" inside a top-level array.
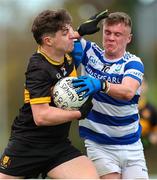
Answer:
[{"left": 73, "top": 76, "right": 140, "bottom": 100}]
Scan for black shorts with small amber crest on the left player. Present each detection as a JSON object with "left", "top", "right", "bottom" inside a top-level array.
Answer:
[{"left": 0, "top": 139, "right": 82, "bottom": 178}]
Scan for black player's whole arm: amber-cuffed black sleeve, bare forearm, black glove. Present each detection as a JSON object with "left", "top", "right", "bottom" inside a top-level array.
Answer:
[{"left": 25, "top": 54, "right": 90, "bottom": 126}]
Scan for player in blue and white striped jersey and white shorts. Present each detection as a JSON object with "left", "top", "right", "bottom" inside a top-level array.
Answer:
[{"left": 72, "top": 12, "right": 148, "bottom": 179}]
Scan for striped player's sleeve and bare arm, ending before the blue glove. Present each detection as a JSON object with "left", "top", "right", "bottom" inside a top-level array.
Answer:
[{"left": 108, "top": 58, "right": 144, "bottom": 100}]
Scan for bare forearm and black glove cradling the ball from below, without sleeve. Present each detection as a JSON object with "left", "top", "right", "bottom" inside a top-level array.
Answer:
[{"left": 31, "top": 97, "right": 93, "bottom": 126}]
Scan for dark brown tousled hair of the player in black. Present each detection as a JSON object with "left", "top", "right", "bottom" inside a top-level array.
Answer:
[{"left": 31, "top": 9, "right": 72, "bottom": 44}]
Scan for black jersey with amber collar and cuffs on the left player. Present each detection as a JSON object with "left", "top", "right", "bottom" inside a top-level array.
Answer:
[{"left": 11, "top": 50, "right": 76, "bottom": 143}]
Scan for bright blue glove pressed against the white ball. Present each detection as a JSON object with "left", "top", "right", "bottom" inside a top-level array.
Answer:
[{"left": 72, "top": 76, "right": 103, "bottom": 98}]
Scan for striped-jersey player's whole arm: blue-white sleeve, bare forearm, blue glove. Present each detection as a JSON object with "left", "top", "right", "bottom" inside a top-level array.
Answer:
[{"left": 73, "top": 61, "right": 144, "bottom": 100}]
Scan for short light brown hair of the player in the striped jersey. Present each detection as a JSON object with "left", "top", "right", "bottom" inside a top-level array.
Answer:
[{"left": 103, "top": 12, "right": 132, "bottom": 28}]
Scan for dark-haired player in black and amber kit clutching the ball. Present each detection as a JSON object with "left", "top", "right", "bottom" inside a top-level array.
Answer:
[{"left": 0, "top": 10, "right": 98, "bottom": 179}]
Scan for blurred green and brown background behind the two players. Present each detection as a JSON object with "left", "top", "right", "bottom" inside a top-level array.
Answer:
[{"left": 0, "top": 0, "right": 157, "bottom": 177}]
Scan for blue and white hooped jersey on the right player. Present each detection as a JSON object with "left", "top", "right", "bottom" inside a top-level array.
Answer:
[{"left": 76, "top": 39, "right": 144, "bottom": 145}]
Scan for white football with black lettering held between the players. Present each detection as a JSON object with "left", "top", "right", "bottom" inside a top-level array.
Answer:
[{"left": 52, "top": 77, "right": 88, "bottom": 110}]
